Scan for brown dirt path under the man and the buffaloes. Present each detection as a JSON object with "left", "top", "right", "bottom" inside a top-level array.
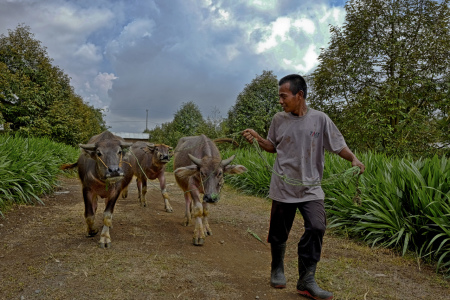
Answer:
[{"left": 0, "top": 173, "right": 450, "bottom": 300}]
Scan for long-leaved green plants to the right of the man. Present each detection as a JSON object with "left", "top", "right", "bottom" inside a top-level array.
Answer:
[{"left": 324, "top": 154, "right": 450, "bottom": 272}]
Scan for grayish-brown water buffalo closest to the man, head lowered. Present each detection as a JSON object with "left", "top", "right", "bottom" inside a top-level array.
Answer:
[{"left": 173, "top": 135, "right": 247, "bottom": 246}]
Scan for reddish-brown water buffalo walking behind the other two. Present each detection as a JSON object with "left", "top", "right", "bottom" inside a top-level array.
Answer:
[{"left": 122, "top": 142, "right": 173, "bottom": 212}]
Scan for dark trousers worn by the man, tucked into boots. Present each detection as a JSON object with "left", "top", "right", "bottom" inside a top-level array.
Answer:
[{"left": 267, "top": 200, "right": 327, "bottom": 262}]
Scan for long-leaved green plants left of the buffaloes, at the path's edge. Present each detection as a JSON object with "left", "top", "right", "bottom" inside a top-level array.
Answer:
[{"left": 0, "top": 135, "right": 80, "bottom": 215}]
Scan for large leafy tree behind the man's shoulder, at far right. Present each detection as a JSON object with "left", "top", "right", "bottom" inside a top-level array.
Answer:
[{"left": 308, "top": 0, "right": 450, "bottom": 155}]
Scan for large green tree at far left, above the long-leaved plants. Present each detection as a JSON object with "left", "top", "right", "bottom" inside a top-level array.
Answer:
[{"left": 0, "top": 25, "right": 106, "bottom": 145}]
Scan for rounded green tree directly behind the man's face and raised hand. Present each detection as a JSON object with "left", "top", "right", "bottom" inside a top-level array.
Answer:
[{"left": 227, "top": 71, "right": 281, "bottom": 143}]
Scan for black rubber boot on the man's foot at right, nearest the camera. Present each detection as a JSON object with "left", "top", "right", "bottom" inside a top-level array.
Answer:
[{"left": 297, "top": 258, "right": 333, "bottom": 300}]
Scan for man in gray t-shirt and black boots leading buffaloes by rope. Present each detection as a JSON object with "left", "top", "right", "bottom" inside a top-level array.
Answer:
[{"left": 242, "top": 74, "right": 365, "bottom": 299}]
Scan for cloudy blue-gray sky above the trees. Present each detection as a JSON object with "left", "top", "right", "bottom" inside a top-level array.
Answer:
[{"left": 0, "top": 0, "right": 345, "bottom": 133}]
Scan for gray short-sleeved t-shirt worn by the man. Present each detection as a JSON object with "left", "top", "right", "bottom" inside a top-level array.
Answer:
[{"left": 267, "top": 109, "right": 347, "bottom": 203}]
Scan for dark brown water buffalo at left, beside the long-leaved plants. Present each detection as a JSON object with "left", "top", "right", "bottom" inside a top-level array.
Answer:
[{"left": 67, "top": 131, "right": 133, "bottom": 248}]
